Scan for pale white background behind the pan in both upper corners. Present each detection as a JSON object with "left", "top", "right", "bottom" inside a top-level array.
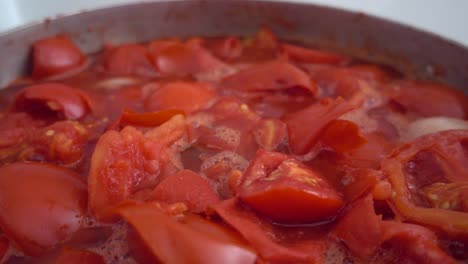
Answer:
[{"left": 0, "top": 0, "right": 468, "bottom": 47}]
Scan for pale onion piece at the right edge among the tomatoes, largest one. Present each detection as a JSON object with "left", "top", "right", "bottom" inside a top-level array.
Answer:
[{"left": 402, "top": 116, "right": 468, "bottom": 141}]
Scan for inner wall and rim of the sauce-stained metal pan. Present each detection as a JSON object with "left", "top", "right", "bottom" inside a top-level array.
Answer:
[{"left": 0, "top": 0, "right": 468, "bottom": 89}]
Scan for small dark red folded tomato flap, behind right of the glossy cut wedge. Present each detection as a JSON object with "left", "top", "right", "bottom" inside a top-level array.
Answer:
[{"left": 320, "top": 120, "right": 367, "bottom": 153}]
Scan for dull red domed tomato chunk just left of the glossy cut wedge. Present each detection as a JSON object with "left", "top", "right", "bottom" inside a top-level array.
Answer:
[{"left": 151, "top": 170, "right": 219, "bottom": 213}]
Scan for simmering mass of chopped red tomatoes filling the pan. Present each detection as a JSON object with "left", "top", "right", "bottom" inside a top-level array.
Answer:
[{"left": 0, "top": 28, "right": 468, "bottom": 264}]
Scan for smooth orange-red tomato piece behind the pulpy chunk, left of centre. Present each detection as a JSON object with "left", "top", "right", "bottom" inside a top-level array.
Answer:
[{"left": 145, "top": 82, "right": 215, "bottom": 114}]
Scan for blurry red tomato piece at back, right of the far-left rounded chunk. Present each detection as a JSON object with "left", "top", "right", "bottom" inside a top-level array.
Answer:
[{"left": 103, "top": 44, "right": 156, "bottom": 76}]
